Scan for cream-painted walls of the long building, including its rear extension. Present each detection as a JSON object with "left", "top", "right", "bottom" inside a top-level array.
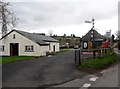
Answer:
[{"left": 0, "top": 31, "right": 59, "bottom": 56}]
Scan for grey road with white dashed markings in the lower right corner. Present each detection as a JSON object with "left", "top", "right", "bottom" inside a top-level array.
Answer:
[{"left": 48, "top": 49, "right": 120, "bottom": 89}]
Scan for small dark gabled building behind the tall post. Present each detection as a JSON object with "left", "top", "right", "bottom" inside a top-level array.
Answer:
[{"left": 82, "top": 29, "right": 104, "bottom": 49}]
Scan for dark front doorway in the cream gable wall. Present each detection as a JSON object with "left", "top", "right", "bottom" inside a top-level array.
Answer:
[{"left": 10, "top": 43, "right": 19, "bottom": 56}]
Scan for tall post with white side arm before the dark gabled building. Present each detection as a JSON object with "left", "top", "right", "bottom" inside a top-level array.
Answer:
[{"left": 85, "top": 18, "right": 95, "bottom": 58}]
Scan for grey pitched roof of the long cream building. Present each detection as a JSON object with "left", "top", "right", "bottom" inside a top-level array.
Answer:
[{"left": 0, "top": 30, "right": 58, "bottom": 44}]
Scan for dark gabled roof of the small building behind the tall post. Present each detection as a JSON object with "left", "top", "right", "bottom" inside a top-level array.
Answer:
[{"left": 82, "top": 29, "right": 104, "bottom": 41}]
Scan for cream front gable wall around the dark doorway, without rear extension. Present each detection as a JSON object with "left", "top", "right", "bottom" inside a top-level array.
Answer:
[{"left": 0, "top": 31, "right": 47, "bottom": 56}]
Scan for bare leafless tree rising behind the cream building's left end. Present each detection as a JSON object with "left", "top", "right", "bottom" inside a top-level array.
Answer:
[{"left": 0, "top": 1, "right": 17, "bottom": 36}]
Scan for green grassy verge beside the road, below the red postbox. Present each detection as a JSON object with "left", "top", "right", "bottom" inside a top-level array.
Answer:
[{"left": 78, "top": 52, "right": 117, "bottom": 69}]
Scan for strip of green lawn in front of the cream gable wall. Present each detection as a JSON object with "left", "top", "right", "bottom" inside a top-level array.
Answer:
[{"left": 0, "top": 56, "right": 34, "bottom": 64}]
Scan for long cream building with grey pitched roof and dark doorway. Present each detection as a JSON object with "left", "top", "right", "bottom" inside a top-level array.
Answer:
[{"left": 0, "top": 30, "right": 59, "bottom": 56}]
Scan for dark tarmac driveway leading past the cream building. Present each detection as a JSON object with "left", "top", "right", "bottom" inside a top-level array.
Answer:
[{"left": 2, "top": 51, "right": 86, "bottom": 87}]
